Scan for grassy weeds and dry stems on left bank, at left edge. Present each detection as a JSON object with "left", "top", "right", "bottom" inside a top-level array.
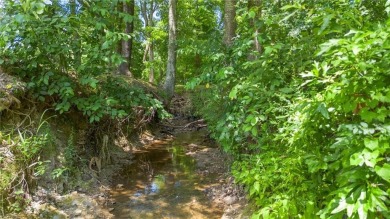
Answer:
[{"left": 0, "top": 113, "right": 52, "bottom": 215}]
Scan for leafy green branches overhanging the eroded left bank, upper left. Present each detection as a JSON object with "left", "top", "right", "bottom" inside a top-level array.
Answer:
[{"left": 0, "top": 0, "right": 168, "bottom": 123}]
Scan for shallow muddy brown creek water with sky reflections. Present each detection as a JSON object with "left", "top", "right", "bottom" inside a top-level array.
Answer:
[{"left": 111, "top": 131, "right": 222, "bottom": 218}]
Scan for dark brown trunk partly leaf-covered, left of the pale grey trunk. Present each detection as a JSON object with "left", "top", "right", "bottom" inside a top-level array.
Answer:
[{"left": 119, "top": 2, "right": 132, "bottom": 76}]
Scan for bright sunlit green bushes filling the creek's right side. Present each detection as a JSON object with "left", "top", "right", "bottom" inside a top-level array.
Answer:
[{"left": 187, "top": 1, "right": 390, "bottom": 218}]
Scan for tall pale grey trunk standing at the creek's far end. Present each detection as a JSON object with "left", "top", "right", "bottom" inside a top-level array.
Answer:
[{"left": 164, "top": 0, "right": 177, "bottom": 102}]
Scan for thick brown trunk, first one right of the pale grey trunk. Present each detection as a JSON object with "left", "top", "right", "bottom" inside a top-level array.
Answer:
[{"left": 223, "top": 0, "right": 237, "bottom": 47}]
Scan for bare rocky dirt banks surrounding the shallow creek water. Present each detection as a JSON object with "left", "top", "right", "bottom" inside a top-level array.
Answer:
[{"left": 1, "top": 90, "right": 247, "bottom": 219}]
